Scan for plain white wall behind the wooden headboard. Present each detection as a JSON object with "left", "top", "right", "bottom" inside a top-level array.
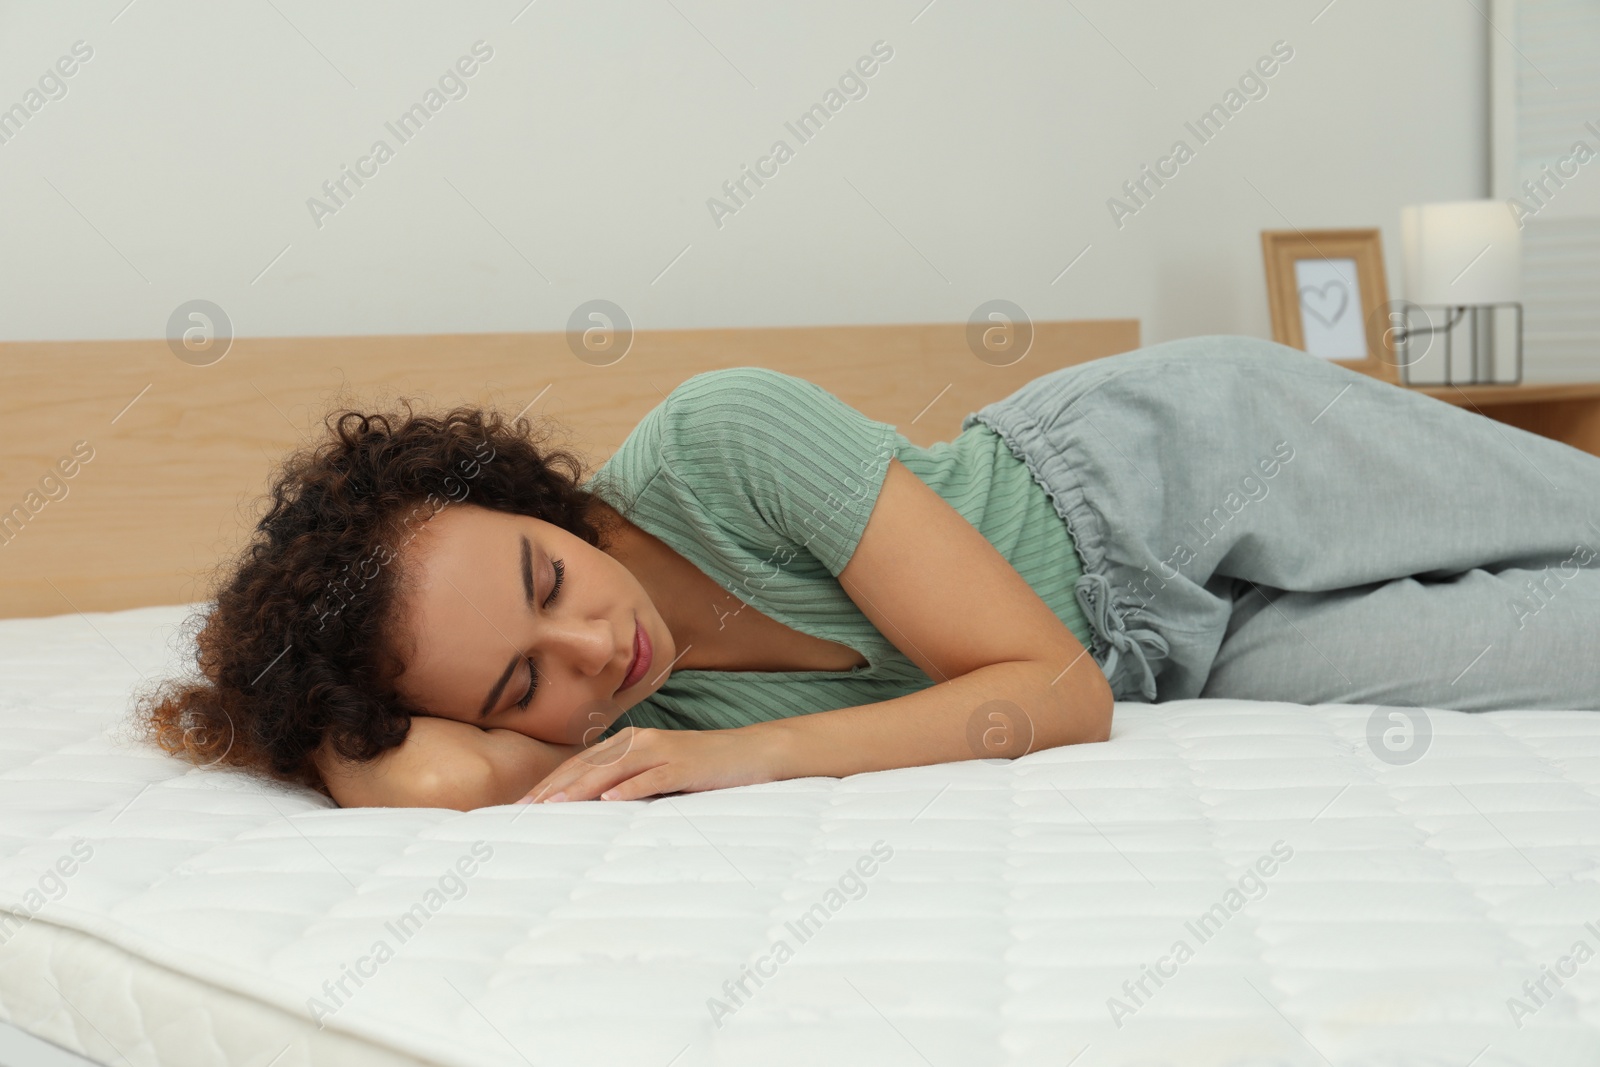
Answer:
[{"left": 0, "top": 0, "right": 1490, "bottom": 342}]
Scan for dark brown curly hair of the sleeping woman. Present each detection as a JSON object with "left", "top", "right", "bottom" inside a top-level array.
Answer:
[{"left": 138, "top": 400, "right": 618, "bottom": 793}]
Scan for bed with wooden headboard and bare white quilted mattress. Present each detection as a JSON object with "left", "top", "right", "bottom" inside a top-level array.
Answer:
[{"left": 0, "top": 323, "right": 1600, "bottom": 1067}]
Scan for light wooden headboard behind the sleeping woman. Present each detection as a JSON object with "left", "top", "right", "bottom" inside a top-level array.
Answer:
[{"left": 0, "top": 320, "right": 1139, "bottom": 617}]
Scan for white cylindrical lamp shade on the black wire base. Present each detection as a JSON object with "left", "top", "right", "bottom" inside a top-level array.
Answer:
[{"left": 1400, "top": 200, "right": 1522, "bottom": 307}]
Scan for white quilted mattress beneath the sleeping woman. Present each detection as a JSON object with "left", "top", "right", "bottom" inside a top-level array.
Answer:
[{"left": 0, "top": 608, "right": 1600, "bottom": 1067}]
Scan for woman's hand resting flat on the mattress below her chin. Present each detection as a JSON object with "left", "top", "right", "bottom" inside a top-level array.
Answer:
[{"left": 517, "top": 726, "right": 786, "bottom": 803}]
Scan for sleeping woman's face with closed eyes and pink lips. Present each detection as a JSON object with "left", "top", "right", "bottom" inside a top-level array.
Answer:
[{"left": 395, "top": 504, "right": 677, "bottom": 744}]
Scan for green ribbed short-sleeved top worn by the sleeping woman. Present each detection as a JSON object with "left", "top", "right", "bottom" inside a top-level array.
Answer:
[{"left": 589, "top": 366, "right": 1090, "bottom": 736}]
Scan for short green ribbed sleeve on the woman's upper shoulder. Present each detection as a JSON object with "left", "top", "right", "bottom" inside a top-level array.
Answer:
[{"left": 659, "top": 366, "right": 904, "bottom": 576}]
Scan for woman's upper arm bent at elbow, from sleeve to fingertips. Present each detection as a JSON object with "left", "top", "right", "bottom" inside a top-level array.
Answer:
[{"left": 531, "top": 459, "right": 1112, "bottom": 800}]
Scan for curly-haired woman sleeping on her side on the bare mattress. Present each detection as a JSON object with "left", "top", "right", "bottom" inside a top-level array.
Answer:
[{"left": 139, "top": 336, "right": 1600, "bottom": 811}]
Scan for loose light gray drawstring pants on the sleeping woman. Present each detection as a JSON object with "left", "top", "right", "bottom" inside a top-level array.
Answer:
[{"left": 962, "top": 336, "right": 1600, "bottom": 710}]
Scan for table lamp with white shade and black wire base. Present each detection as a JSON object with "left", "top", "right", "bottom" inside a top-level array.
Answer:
[{"left": 1394, "top": 200, "right": 1522, "bottom": 386}]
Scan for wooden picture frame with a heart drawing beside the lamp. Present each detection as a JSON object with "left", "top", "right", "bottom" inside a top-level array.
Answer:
[{"left": 1261, "top": 229, "right": 1400, "bottom": 386}]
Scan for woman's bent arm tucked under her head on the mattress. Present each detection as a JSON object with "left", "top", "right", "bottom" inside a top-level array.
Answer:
[{"left": 315, "top": 715, "right": 582, "bottom": 811}]
